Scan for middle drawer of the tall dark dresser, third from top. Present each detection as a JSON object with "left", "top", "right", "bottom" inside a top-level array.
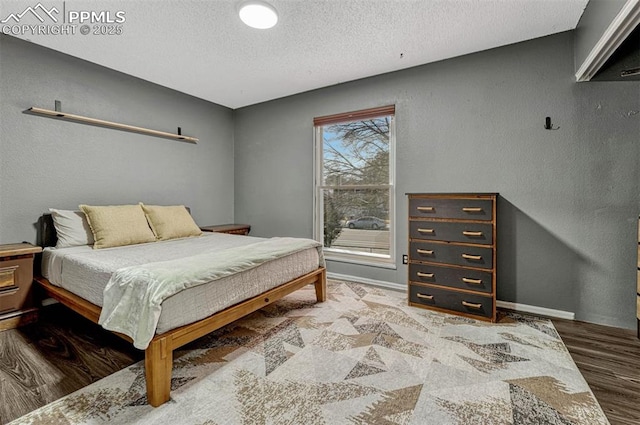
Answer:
[{"left": 409, "top": 242, "right": 493, "bottom": 269}]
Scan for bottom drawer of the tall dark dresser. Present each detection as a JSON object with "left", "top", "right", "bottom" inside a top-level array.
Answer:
[{"left": 409, "top": 285, "right": 493, "bottom": 317}]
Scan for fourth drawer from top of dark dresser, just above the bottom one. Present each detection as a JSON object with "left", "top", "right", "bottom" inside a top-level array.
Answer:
[{"left": 409, "top": 263, "right": 493, "bottom": 293}]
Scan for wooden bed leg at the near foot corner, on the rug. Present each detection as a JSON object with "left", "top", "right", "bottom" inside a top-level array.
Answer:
[{"left": 144, "top": 338, "right": 173, "bottom": 407}]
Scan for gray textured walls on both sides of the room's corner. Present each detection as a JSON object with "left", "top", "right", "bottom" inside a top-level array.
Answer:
[{"left": 0, "top": 33, "right": 640, "bottom": 328}]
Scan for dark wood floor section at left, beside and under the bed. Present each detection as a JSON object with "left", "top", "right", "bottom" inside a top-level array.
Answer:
[{"left": 0, "top": 304, "right": 144, "bottom": 424}]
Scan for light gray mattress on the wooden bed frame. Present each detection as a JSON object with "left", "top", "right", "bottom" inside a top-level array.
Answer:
[{"left": 42, "top": 232, "right": 320, "bottom": 334}]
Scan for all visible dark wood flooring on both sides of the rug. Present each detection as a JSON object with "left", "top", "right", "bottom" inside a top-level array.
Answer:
[{"left": 0, "top": 305, "right": 640, "bottom": 425}]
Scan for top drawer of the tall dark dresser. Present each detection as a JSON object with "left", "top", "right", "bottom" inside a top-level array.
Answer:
[{"left": 409, "top": 198, "right": 493, "bottom": 220}]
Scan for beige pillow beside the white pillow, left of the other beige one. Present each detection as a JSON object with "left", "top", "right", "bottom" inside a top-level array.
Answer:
[{"left": 80, "top": 205, "right": 156, "bottom": 249}]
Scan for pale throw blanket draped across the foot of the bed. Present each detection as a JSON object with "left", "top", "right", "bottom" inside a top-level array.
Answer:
[{"left": 98, "top": 238, "right": 324, "bottom": 350}]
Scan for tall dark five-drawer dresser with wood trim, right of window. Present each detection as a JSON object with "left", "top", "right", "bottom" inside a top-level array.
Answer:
[{"left": 408, "top": 193, "right": 498, "bottom": 322}]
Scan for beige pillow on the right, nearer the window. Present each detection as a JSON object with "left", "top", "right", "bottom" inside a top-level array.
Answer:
[{"left": 140, "top": 204, "right": 202, "bottom": 241}]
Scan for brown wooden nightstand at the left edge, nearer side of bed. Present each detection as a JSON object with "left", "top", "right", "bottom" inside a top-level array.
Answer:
[{"left": 0, "top": 243, "right": 42, "bottom": 331}]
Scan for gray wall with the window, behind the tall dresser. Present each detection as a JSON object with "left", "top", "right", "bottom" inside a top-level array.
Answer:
[{"left": 235, "top": 32, "right": 640, "bottom": 328}]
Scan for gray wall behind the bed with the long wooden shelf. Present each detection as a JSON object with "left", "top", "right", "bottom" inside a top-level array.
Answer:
[{"left": 0, "top": 35, "right": 233, "bottom": 243}]
